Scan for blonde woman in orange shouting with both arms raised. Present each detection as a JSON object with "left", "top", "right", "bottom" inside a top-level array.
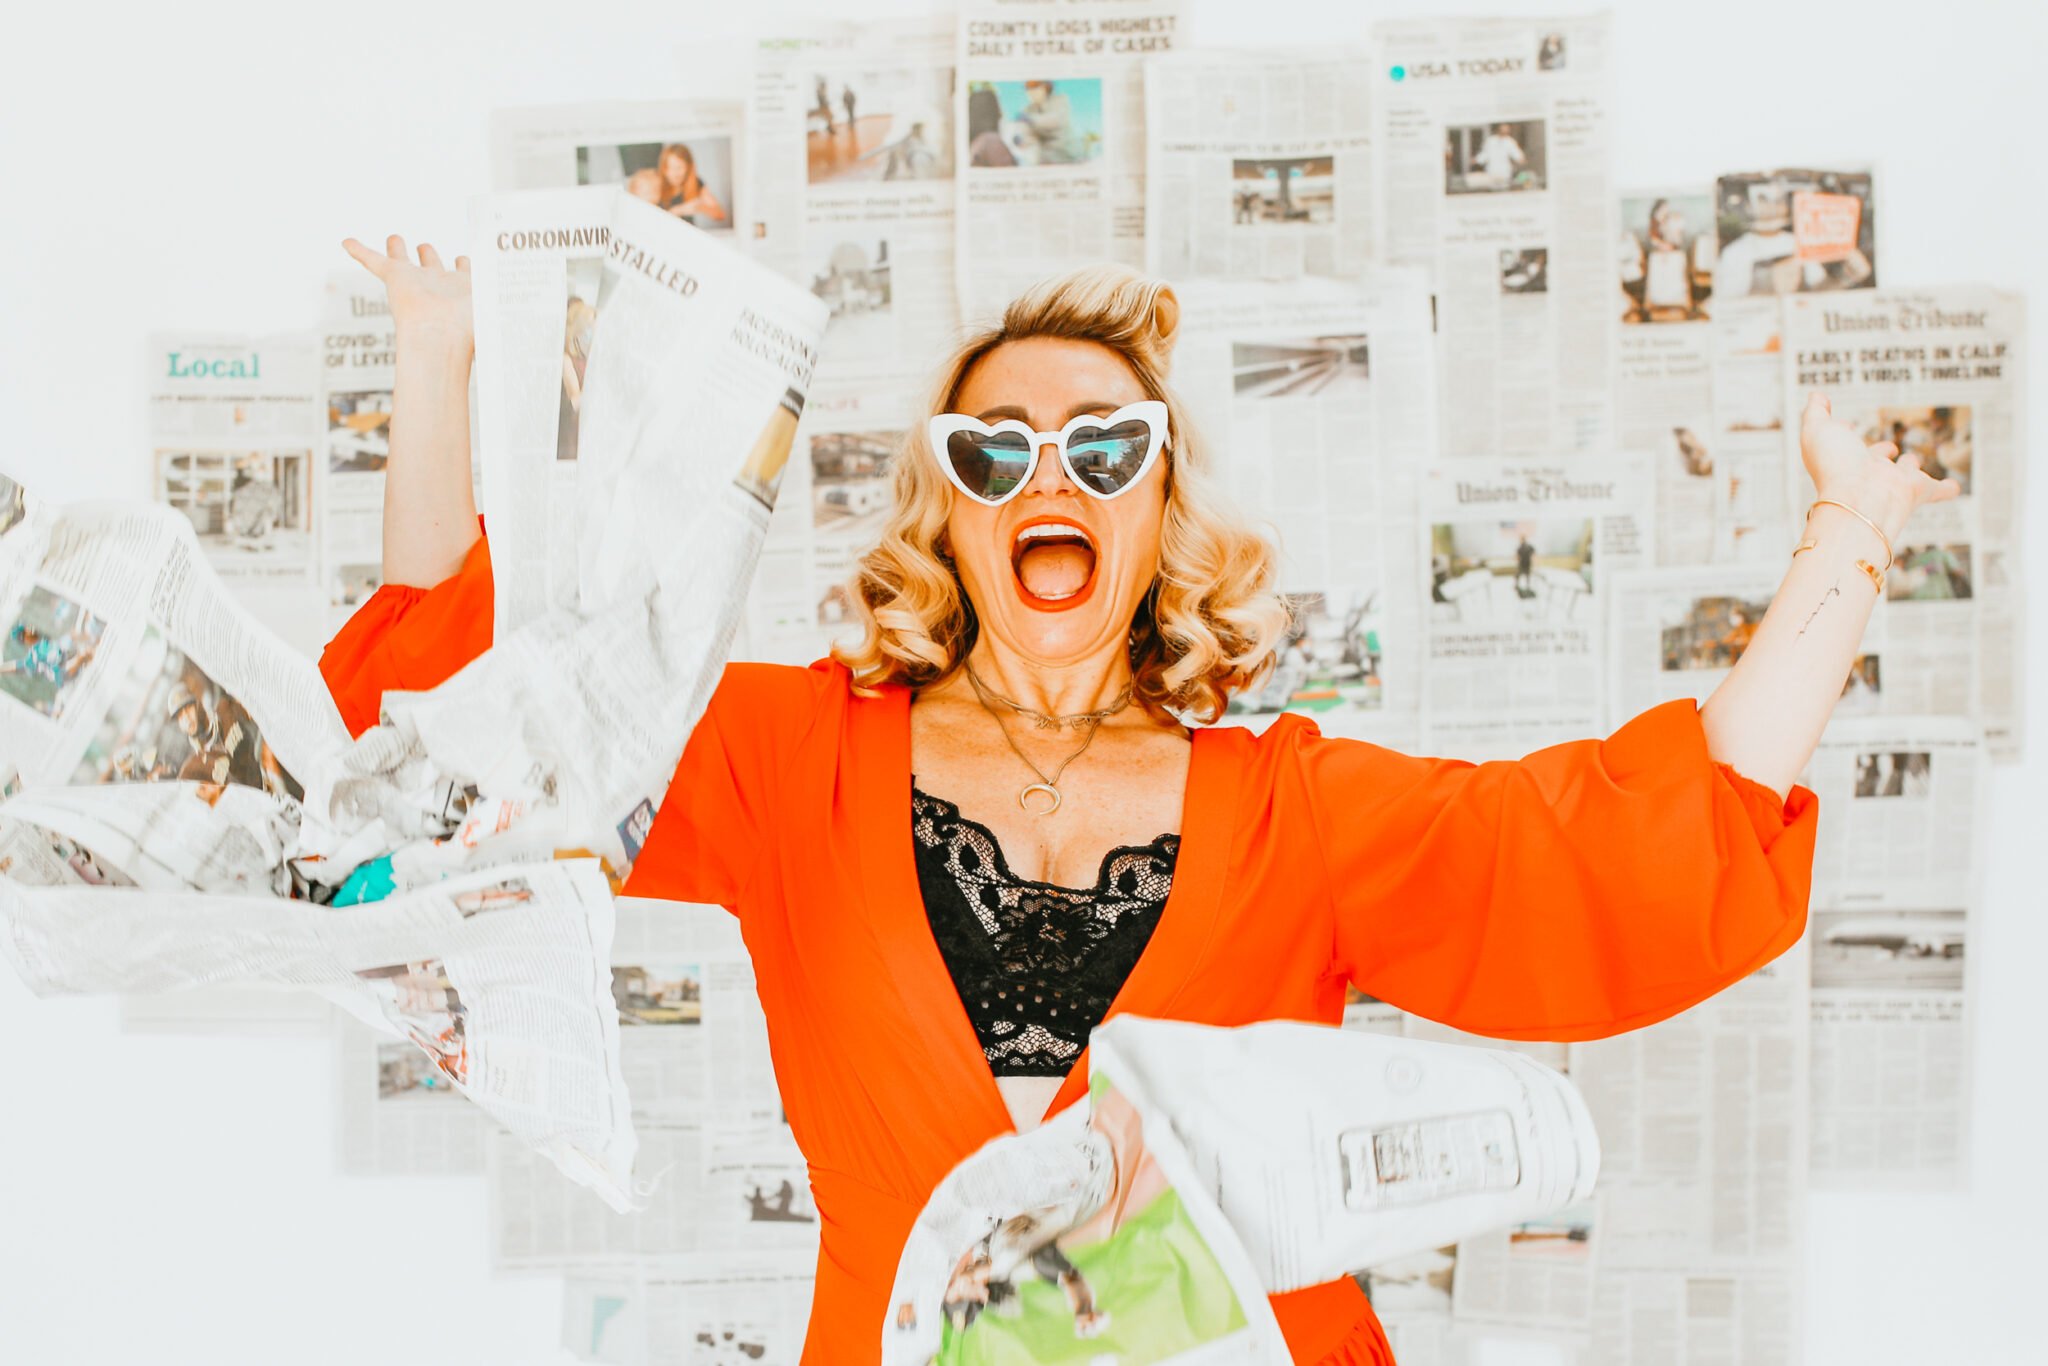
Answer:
[{"left": 322, "top": 238, "right": 1952, "bottom": 1364}]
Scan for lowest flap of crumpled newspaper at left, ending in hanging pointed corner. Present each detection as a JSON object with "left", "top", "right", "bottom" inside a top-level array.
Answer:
[{"left": 0, "top": 864, "right": 635, "bottom": 1208}]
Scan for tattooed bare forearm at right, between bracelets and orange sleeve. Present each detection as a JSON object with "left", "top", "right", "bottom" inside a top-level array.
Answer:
[{"left": 1700, "top": 504, "right": 1884, "bottom": 797}]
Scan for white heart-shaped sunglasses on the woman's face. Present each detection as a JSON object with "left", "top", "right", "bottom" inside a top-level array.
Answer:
[{"left": 930, "top": 399, "right": 1165, "bottom": 508}]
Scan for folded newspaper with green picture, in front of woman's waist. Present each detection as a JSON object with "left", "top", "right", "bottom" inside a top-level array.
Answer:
[{"left": 883, "top": 1016, "right": 1599, "bottom": 1366}]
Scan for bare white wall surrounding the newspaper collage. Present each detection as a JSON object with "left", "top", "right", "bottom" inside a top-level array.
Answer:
[{"left": 0, "top": 0, "right": 2048, "bottom": 1366}]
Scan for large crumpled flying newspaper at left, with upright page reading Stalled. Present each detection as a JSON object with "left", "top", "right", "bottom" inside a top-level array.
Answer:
[{"left": 0, "top": 195, "right": 825, "bottom": 1208}]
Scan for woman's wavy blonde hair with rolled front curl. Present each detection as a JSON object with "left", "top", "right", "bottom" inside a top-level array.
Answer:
[{"left": 831, "top": 266, "right": 1288, "bottom": 721}]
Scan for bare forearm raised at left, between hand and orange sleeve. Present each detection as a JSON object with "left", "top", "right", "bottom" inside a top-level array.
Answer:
[{"left": 383, "top": 330, "right": 477, "bottom": 588}]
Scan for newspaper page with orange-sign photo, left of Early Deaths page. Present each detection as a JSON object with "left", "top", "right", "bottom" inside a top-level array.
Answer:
[{"left": 1706, "top": 164, "right": 1878, "bottom": 561}]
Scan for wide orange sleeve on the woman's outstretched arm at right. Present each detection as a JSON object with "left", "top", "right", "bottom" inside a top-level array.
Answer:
[{"left": 1280, "top": 700, "right": 1819, "bottom": 1040}]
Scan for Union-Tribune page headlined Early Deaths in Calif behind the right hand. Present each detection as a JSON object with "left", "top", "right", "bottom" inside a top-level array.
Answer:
[{"left": 1782, "top": 285, "right": 2028, "bottom": 760}]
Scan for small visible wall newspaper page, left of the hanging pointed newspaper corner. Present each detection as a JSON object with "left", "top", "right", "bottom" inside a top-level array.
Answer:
[{"left": 339, "top": 997, "right": 489, "bottom": 1176}]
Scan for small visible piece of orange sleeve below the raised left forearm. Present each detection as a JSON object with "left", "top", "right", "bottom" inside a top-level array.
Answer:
[{"left": 319, "top": 537, "right": 492, "bottom": 735}]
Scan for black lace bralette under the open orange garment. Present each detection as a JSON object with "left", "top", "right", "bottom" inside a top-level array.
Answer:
[{"left": 909, "top": 782, "right": 1180, "bottom": 1077}]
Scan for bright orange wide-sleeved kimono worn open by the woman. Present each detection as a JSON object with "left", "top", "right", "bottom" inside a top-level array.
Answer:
[{"left": 322, "top": 541, "right": 1817, "bottom": 1366}]
